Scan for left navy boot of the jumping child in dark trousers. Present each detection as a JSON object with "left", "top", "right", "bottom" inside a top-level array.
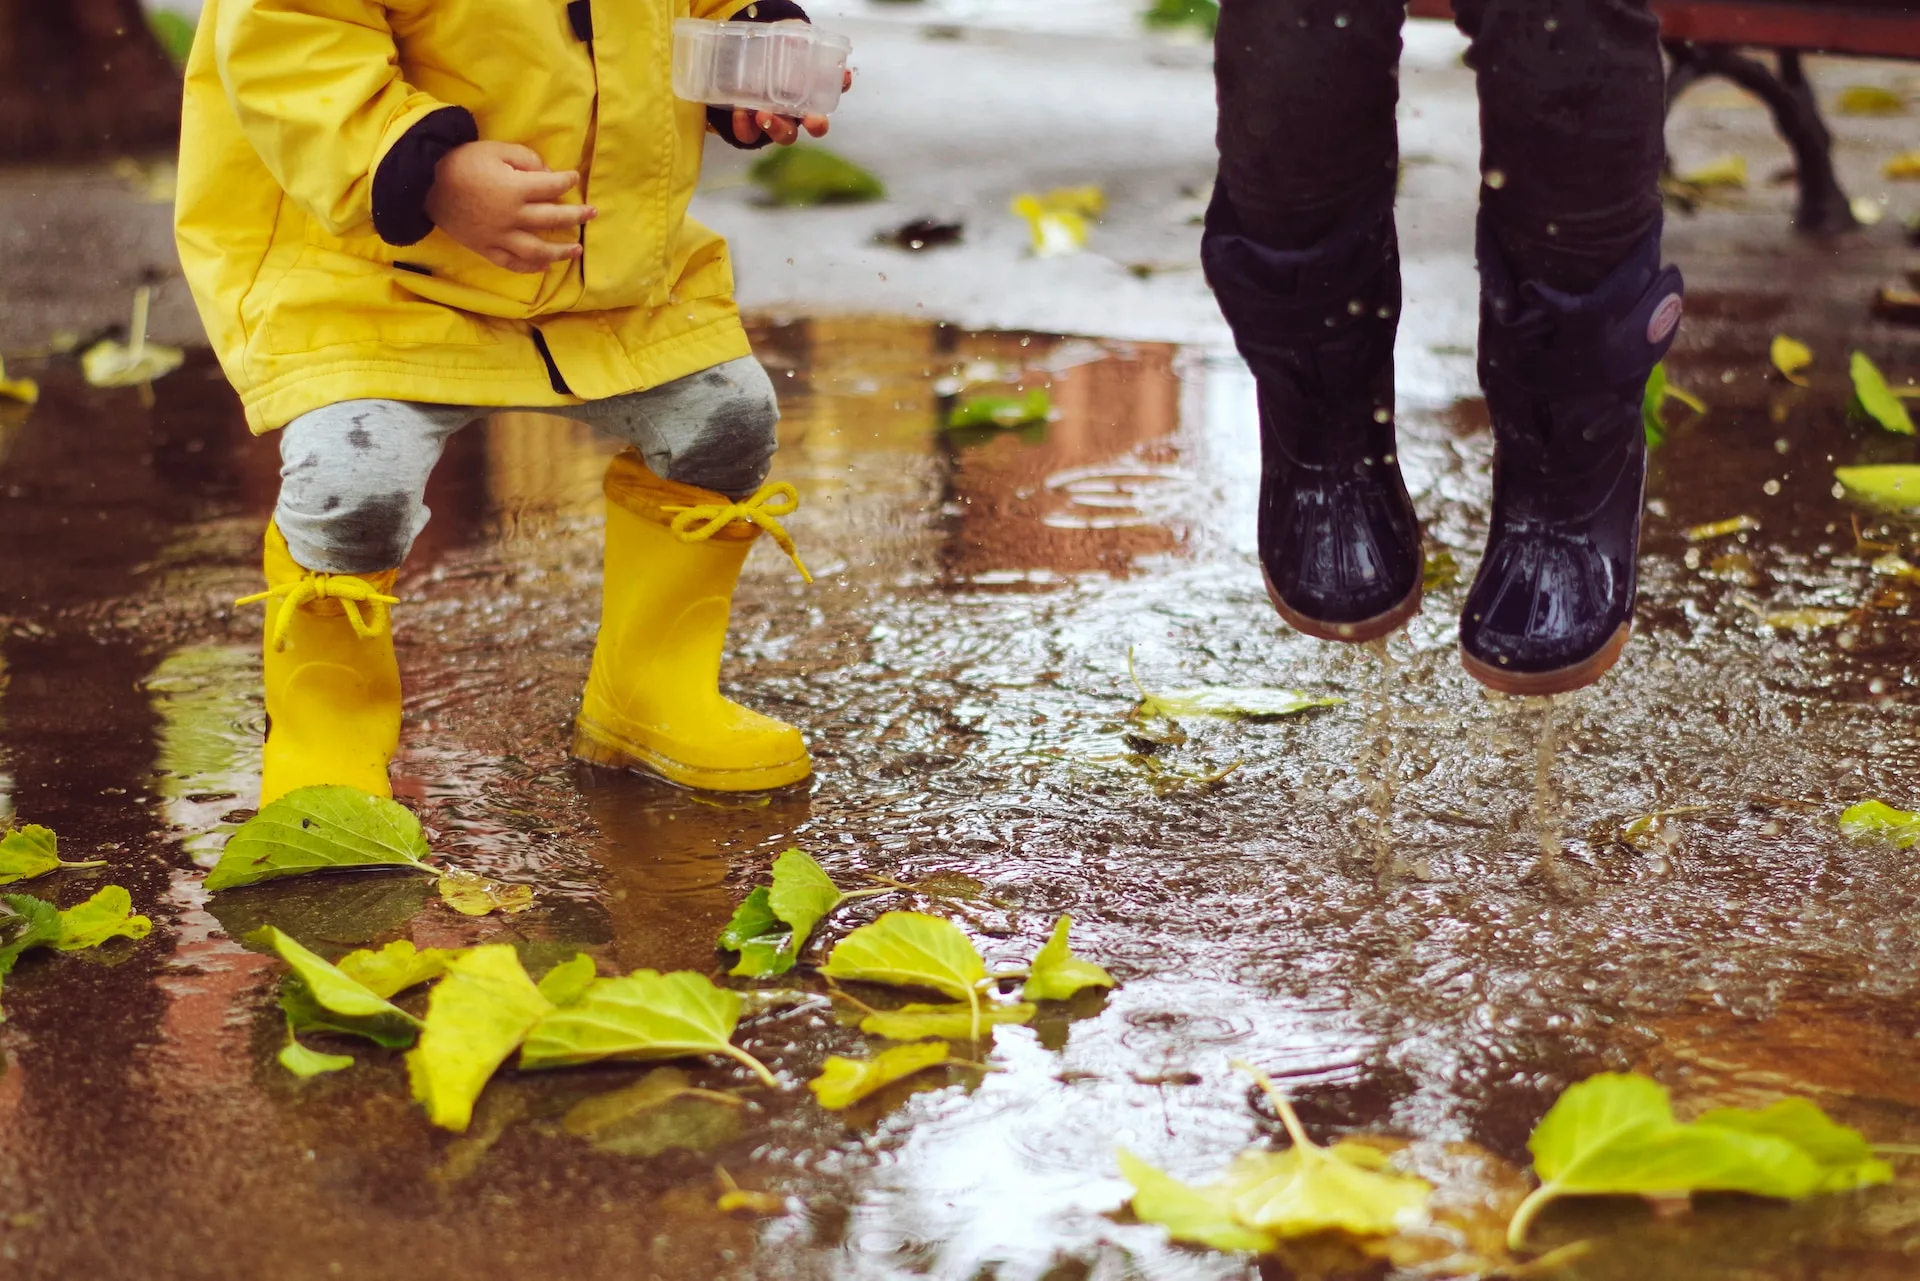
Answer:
[{"left": 1200, "top": 175, "right": 1423, "bottom": 641}]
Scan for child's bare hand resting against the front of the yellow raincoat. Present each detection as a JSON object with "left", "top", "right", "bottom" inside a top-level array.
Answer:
[{"left": 426, "top": 142, "right": 599, "bottom": 273}]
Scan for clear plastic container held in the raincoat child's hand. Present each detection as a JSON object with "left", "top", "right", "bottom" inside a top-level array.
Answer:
[{"left": 674, "top": 17, "right": 852, "bottom": 115}]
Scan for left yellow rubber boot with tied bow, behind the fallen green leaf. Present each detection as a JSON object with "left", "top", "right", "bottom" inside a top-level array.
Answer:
[{"left": 236, "top": 524, "right": 399, "bottom": 805}]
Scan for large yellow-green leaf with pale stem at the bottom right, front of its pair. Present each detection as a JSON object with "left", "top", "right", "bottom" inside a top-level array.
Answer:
[{"left": 1507, "top": 1072, "right": 1828, "bottom": 1250}]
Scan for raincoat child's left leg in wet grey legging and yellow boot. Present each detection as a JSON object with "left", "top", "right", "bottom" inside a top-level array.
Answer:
[{"left": 248, "top": 399, "right": 474, "bottom": 805}]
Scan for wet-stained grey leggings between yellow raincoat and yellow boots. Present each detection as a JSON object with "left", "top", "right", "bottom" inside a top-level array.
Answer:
[{"left": 273, "top": 355, "right": 780, "bottom": 574}]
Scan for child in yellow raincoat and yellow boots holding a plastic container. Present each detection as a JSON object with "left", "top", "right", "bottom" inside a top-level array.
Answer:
[{"left": 177, "top": 0, "right": 844, "bottom": 805}]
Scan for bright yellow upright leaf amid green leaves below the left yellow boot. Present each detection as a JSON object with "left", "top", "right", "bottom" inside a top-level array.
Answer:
[{"left": 407, "top": 943, "right": 553, "bottom": 1131}]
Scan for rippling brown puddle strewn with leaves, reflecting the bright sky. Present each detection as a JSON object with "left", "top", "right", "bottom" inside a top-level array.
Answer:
[{"left": 0, "top": 313, "right": 1920, "bottom": 1281}]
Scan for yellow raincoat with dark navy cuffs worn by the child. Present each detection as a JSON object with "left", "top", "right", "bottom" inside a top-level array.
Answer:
[{"left": 175, "top": 0, "right": 749, "bottom": 432}]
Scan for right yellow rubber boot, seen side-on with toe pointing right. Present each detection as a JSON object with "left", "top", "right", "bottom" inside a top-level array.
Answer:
[{"left": 574, "top": 449, "right": 814, "bottom": 791}]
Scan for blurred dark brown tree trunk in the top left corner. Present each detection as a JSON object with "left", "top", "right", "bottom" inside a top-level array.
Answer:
[{"left": 0, "top": 0, "right": 180, "bottom": 161}]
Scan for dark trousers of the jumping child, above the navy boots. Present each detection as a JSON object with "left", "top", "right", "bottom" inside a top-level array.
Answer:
[{"left": 1213, "top": 0, "right": 1665, "bottom": 294}]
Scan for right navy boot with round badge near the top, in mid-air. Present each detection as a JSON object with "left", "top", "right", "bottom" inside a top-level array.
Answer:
[{"left": 1459, "top": 222, "right": 1682, "bottom": 693}]
